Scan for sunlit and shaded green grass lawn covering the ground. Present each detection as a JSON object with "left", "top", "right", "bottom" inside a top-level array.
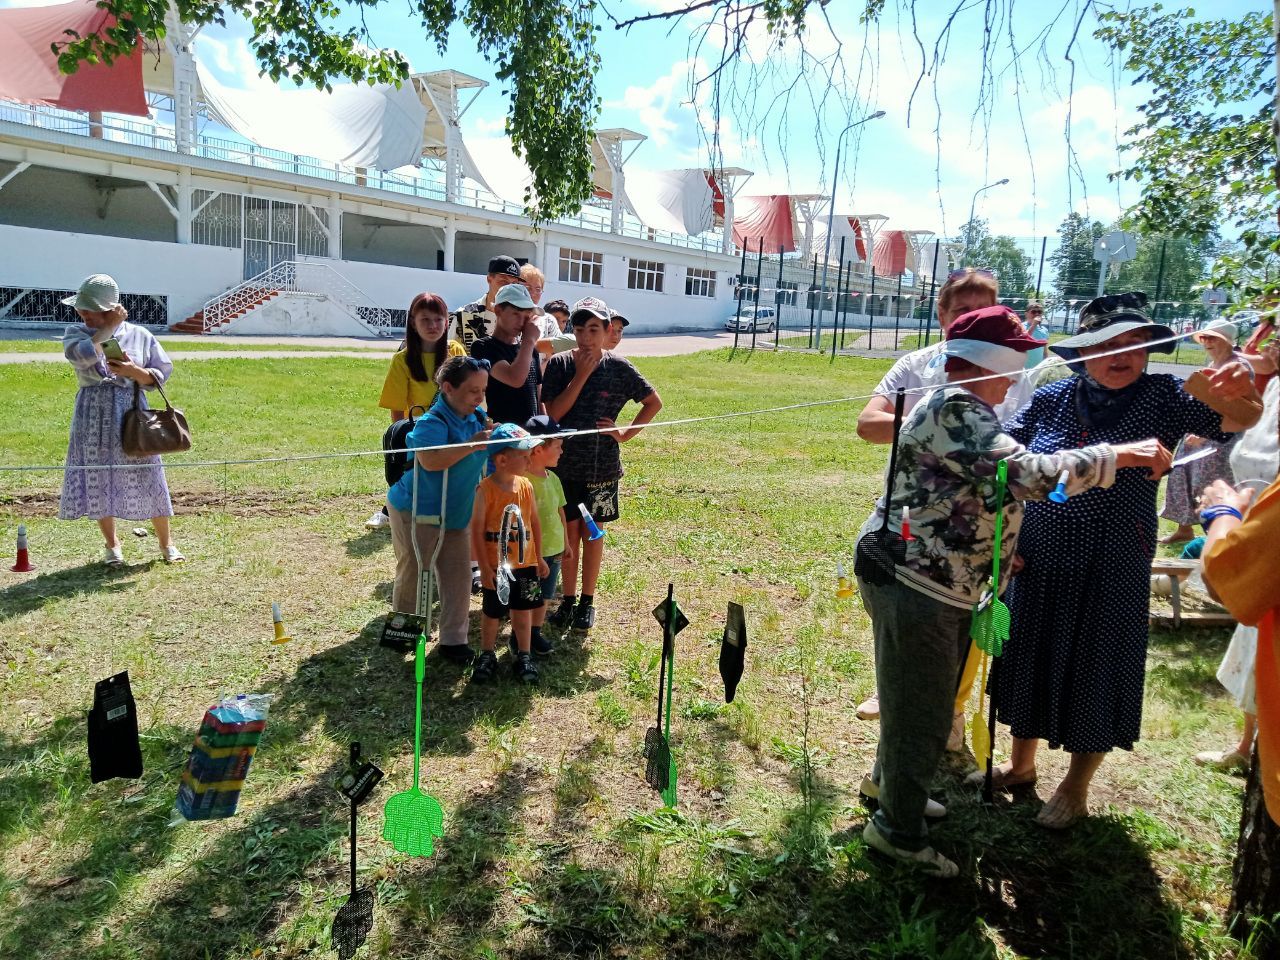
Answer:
[{"left": 0, "top": 351, "right": 1242, "bottom": 960}]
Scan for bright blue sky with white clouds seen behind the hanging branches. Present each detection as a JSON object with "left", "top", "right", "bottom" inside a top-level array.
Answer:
[{"left": 0, "top": 0, "right": 1270, "bottom": 237}]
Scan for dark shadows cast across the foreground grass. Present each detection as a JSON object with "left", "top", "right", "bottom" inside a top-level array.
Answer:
[{"left": 0, "top": 618, "right": 1218, "bottom": 960}]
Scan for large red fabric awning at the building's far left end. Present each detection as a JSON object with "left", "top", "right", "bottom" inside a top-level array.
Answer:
[{"left": 0, "top": 0, "right": 148, "bottom": 116}]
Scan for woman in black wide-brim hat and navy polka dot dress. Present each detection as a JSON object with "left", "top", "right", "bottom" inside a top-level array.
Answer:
[{"left": 977, "top": 293, "right": 1256, "bottom": 829}]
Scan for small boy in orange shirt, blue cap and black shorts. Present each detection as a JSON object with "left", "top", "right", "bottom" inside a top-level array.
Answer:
[{"left": 471, "top": 424, "right": 548, "bottom": 684}]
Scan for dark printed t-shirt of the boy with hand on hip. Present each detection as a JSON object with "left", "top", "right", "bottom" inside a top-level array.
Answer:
[{"left": 543, "top": 351, "right": 653, "bottom": 484}]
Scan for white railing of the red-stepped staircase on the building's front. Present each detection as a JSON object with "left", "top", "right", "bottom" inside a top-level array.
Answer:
[{"left": 201, "top": 260, "right": 403, "bottom": 337}]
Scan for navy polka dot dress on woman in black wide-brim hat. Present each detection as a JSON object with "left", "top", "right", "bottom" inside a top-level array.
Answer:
[{"left": 993, "top": 374, "right": 1225, "bottom": 753}]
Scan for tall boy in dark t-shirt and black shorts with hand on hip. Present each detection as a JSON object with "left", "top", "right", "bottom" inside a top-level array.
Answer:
[{"left": 543, "top": 297, "right": 662, "bottom": 630}]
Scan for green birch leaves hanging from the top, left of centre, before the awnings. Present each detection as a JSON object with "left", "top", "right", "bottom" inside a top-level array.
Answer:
[{"left": 54, "top": 0, "right": 600, "bottom": 219}]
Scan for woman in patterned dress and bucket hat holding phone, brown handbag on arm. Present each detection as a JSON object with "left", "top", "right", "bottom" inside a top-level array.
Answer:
[{"left": 58, "top": 274, "right": 186, "bottom": 567}]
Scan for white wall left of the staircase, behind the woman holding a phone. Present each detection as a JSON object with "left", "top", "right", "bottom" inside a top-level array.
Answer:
[{"left": 0, "top": 224, "right": 243, "bottom": 324}]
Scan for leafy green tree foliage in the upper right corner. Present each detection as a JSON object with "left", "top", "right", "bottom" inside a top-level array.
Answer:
[{"left": 1094, "top": 4, "right": 1276, "bottom": 238}]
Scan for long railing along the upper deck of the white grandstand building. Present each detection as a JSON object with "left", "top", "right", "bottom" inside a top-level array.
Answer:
[{"left": 0, "top": 100, "right": 722, "bottom": 252}]
